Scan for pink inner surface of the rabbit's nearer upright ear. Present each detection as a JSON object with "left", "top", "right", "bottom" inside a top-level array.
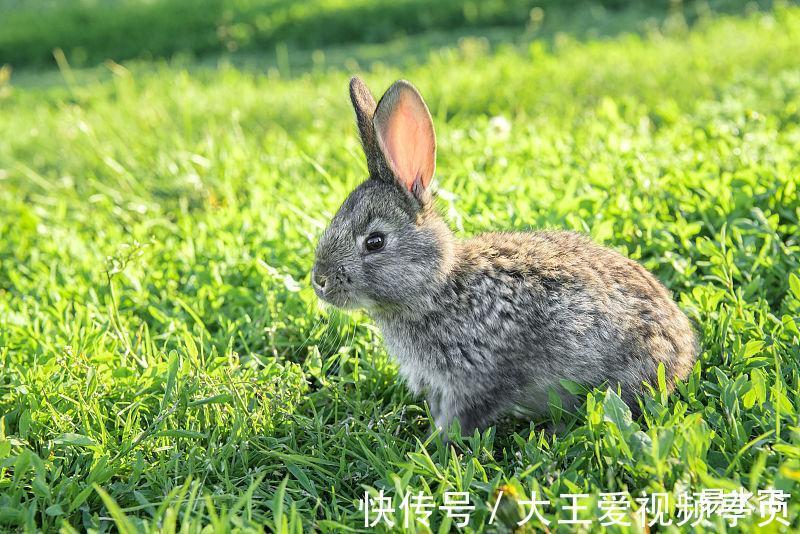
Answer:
[{"left": 379, "top": 93, "right": 436, "bottom": 190}]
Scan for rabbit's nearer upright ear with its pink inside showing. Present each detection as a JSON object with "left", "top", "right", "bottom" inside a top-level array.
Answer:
[{"left": 372, "top": 80, "right": 436, "bottom": 194}]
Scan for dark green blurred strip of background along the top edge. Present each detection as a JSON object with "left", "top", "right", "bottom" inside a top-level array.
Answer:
[{"left": 0, "top": 0, "right": 772, "bottom": 74}]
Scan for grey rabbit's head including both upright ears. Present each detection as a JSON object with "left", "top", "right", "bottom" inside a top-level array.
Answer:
[{"left": 312, "top": 78, "right": 454, "bottom": 311}]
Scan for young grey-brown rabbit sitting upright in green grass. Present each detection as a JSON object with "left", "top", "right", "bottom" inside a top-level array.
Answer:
[{"left": 311, "top": 77, "right": 698, "bottom": 435}]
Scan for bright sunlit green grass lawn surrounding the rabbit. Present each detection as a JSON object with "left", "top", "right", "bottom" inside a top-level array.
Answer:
[{"left": 0, "top": 2, "right": 800, "bottom": 532}]
